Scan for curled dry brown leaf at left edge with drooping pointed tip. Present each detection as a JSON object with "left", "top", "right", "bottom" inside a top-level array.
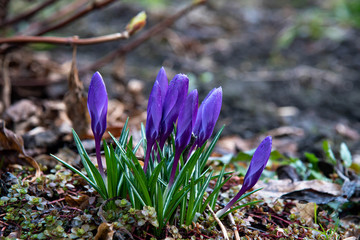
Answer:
[{"left": 0, "top": 121, "right": 41, "bottom": 181}]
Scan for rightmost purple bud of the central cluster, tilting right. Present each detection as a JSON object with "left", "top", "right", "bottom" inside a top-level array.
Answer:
[{"left": 193, "top": 87, "right": 222, "bottom": 147}]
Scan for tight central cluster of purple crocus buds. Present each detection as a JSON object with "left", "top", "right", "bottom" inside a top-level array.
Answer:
[{"left": 144, "top": 68, "right": 222, "bottom": 185}]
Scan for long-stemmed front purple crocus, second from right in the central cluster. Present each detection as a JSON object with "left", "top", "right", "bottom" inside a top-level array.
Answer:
[{"left": 169, "top": 89, "right": 199, "bottom": 186}]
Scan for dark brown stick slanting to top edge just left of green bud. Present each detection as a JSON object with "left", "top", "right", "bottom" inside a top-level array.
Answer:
[{"left": 34, "top": 0, "right": 115, "bottom": 36}]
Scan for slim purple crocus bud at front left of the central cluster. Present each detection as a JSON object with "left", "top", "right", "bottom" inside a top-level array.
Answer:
[{"left": 144, "top": 81, "right": 162, "bottom": 172}]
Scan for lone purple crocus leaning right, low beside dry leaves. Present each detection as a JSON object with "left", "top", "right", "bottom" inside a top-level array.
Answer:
[{"left": 216, "top": 136, "right": 272, "bottom": 217}]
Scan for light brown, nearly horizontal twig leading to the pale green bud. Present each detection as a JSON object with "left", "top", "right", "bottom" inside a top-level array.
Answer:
[{"left": 0, "top": 31, "right": 129, "bottom": 45}]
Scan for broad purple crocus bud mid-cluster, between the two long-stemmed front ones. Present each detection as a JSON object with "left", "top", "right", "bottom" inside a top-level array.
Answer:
[{"left": 159, "top": 74, "right": 189, "bottom": 149}]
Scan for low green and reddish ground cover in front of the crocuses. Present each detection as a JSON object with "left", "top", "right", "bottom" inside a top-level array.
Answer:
[{"left": 0, "top": 162, "right": 356, "bottom": 239}]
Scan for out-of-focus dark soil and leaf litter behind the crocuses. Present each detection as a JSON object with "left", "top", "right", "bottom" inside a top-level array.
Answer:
[{"left": 0, "top": 0, "right": 360, "bottom": 158}]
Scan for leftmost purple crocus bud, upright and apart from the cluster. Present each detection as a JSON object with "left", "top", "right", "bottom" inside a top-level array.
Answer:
[{"left": 87, "top": 72, "right": 108, "bottom": 177}]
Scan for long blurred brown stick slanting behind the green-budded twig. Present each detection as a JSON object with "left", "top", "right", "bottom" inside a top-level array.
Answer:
[{"left": 80, "top": 0, "right": 206, "bottom": 72}]
